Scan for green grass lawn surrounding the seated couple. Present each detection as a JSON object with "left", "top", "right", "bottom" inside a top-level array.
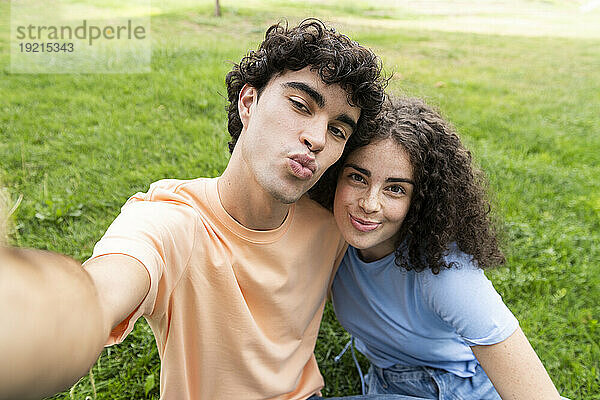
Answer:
[{"left": 0, "top": 0, "right": 600, "bottom": 399}]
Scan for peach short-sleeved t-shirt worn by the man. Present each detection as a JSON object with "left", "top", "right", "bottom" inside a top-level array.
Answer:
[{"left": 86, "top": 178, "right": 345, "bottom": 400}]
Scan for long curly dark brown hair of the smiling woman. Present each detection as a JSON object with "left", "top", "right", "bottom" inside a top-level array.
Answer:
[{"left": 310, "top": 98, "right": 505, "bottom": 274}]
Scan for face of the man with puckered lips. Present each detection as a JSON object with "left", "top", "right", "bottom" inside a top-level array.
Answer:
[{"left": 236, "top": 67, "right": 360, "bottom": 204}]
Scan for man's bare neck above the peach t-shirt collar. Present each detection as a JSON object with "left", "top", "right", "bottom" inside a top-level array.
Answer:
[{"left": 217, "top": 166, "right": 290, "bottom": 230}]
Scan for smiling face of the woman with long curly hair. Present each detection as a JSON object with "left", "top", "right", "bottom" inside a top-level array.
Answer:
[{"left": 333, "top": 139, "right": 414, "bottom": 261}]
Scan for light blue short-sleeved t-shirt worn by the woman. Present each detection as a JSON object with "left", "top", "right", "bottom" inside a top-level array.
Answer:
[{"left": 332, "top": 246, "right": 519, "bottom": 377}]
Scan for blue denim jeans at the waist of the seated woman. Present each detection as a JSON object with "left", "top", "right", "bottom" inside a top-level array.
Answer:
[{"left": 367, "top": 365, "right": 502, "bottom": 400}]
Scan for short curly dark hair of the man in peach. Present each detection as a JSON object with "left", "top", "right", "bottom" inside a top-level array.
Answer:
[{"left": 225, "top": 18, "right": 387, "bottom": 152}]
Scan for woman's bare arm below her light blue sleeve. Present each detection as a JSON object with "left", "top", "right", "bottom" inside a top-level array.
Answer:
[{"left": 471, "top": 328, "right": 560, "bottom": 400}]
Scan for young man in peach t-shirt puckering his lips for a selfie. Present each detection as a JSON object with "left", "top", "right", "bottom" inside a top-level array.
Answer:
[{"left": 0, "top": 20, "right": 426, "bottom": 400}]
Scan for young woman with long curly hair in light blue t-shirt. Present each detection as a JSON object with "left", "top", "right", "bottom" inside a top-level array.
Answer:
[{"left": 312, "top": 99, "right": 560, "bottom": 400}]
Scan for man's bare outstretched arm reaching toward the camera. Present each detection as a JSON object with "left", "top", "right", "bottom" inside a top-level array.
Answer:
[{"left": 0, "top": 246, "right": 150, "bottom": 399}]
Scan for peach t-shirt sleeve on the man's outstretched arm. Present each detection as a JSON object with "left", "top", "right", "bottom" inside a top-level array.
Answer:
[{"left": 84, "top": 186, "right": 196, "bottom": 346}]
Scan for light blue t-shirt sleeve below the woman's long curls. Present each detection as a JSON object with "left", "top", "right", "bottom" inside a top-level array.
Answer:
[{"left": 422, "top": 252, "right": 519, "bottom": 346}]
